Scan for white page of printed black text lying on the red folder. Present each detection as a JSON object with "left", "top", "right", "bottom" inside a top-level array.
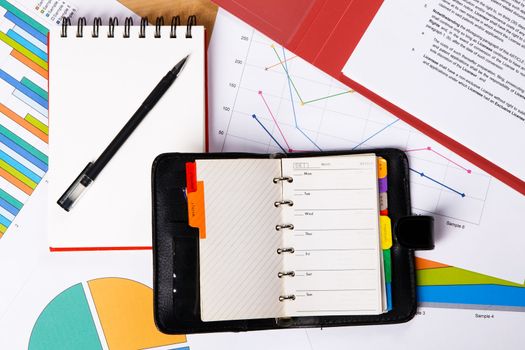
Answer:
[{"left": 343, "top": 0, "right": 525, "bottom": 180}]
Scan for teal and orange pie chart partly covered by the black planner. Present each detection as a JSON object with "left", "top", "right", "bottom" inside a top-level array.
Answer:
[{"left": 29, "top": 277, "right": 189, "bottom": 350}]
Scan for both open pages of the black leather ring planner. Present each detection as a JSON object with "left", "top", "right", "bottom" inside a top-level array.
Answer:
[{"left": 196, "top": 154, "right": 385, "bottom": 321}]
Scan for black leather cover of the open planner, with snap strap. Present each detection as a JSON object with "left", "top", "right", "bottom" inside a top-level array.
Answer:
[{"left": 152, "top": 149, "right": 433, "bottom": 334}]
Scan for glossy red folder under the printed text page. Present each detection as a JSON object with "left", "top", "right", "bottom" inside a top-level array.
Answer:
[{"left": 213, "top": 0, "right": 525, "bottom": 195}]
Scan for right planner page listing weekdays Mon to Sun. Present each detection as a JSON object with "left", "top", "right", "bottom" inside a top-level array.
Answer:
[{"left": 281, "top": 154, "right": 383, "bottom": 316}]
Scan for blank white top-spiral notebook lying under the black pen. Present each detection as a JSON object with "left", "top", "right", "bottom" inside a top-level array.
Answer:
[{"left": 48, "top": 17, "right": 205, "bottom": 251}]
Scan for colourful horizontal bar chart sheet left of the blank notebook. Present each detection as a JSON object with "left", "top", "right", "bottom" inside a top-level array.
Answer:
[{"left": 0, "top": 0, "right": 49, "bottom": 238}]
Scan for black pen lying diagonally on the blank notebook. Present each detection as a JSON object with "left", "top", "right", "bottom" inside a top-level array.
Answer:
[{"left": 57, "top": 55, "right": 189, "bottom": 211}]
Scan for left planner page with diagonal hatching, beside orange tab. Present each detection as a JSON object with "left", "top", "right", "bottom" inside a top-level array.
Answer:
[{"left": 196, "top": 159, "right": 283, "bottom": 321}]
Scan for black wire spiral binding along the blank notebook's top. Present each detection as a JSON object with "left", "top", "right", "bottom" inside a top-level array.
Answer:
[{"left": 60, "top": 15, "right": 197, "bottom": 38}]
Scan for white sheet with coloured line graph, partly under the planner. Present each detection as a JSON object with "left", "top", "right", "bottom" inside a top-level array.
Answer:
[{"left": 209, "top": 10, "right": 525, "bottom": 283}]
